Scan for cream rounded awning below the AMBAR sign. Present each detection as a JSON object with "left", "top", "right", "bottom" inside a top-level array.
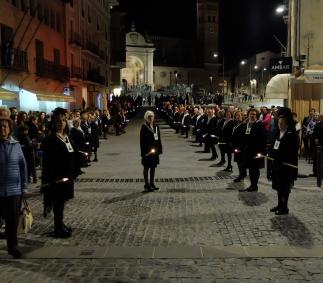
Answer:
[{"left": 266, "top": 74, "right": 290, "bottom": 99}]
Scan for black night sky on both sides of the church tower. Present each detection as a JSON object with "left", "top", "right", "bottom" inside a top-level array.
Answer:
[{"left": 117, "top": 0, "right": 287, "bottom": 68}]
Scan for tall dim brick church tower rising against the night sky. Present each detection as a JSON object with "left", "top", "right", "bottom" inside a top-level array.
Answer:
[{"left": 196, "top": 0, "right": 219, "bottom": 67}]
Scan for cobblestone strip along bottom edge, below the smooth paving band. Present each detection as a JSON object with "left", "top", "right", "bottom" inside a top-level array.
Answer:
[{"left": 0, "top": 258, "right": 323, "bottom": 283}]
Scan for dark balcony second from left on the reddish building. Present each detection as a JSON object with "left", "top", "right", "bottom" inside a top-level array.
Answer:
[{"left": 36, "top": 58, "right": 70, "bottom": 82}]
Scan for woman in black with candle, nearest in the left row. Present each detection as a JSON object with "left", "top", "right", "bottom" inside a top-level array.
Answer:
[{"left": 41, "top": 110, "right": 80, "bottom": 238}]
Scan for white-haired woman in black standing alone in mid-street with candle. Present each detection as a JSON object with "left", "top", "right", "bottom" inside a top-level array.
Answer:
[{"left": 140, "top": 111, "right": 163, "bottom": 192}]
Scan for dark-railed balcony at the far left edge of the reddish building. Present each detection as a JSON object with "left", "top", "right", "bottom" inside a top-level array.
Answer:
[{"left": 0, "top": 45, "right": 28, "bottom": 72}]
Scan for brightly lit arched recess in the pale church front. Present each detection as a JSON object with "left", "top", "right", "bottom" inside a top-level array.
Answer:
[{"left": 122, "top": 56, "right": 145, "bottom": 86}]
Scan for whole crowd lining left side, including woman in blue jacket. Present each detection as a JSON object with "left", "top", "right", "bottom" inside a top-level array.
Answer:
[{"left": 0, "top": 96, "right": 140, "bottom": 258}]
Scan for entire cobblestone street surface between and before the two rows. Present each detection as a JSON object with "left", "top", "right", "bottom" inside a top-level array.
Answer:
[{"left": 0, "top": 112, "right": 323, "bottom": 282}]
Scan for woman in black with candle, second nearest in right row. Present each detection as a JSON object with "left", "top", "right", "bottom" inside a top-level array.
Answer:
[{"left": 242, "top": 108, "right": 266, "bottom": 192}]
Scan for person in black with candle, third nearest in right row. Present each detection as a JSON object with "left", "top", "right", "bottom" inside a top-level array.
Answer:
[{"left": 232, "top": 111, "right": 247, "bottom": 183}]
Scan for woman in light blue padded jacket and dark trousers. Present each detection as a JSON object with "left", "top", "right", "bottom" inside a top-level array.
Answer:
[{"left": 0, "top": 111, "right": 28, "bottom": 258}]
